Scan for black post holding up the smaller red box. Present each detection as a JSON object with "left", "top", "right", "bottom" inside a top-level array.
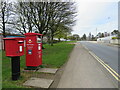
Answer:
[{"left": 11, "top": 56, "right": 20, "bottom": 80}]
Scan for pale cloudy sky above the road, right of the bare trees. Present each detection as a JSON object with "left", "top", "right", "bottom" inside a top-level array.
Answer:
[{"left": 72, "top": 0, "right": 119, "bottom": 36}]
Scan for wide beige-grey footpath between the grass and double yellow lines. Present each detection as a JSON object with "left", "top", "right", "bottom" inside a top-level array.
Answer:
[{"left": 57, "top": 43, "right": 117, "bottom": 88}]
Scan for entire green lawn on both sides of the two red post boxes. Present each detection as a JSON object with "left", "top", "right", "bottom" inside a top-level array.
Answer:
[{"left": 2, "top": 41, "right": 75, "bottom": 88}]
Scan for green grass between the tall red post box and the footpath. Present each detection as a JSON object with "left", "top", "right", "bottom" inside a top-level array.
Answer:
[{"left": 43, "top": 42, "right": 74, "bottom": 68}]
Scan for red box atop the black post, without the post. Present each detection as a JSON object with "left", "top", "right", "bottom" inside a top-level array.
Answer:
[{"left": 4, "top": 37, "right": 24, "bottom": 57}]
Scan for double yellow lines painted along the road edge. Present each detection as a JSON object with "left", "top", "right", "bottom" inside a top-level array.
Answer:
[{"left": 89, "top": 51, "right": 120, "bottom": 81}]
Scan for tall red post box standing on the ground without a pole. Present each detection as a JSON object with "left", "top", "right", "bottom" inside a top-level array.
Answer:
[{"left": 25, "top": 33, "right": 42, "bottom": 67}]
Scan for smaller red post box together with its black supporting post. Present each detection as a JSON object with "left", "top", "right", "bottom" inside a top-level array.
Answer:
[{"left": 4, "top": 37, "right": 24, "bottom": 80}]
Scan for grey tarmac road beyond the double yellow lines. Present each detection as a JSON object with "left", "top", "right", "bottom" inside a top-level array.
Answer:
[{"left": 80, "top": 41, "right": 118, "bottom": 72}]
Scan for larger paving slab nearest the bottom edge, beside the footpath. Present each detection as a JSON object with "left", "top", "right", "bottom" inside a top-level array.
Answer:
[{"left": 23, "top": 77, "right": 53, "bottom": 88}]
